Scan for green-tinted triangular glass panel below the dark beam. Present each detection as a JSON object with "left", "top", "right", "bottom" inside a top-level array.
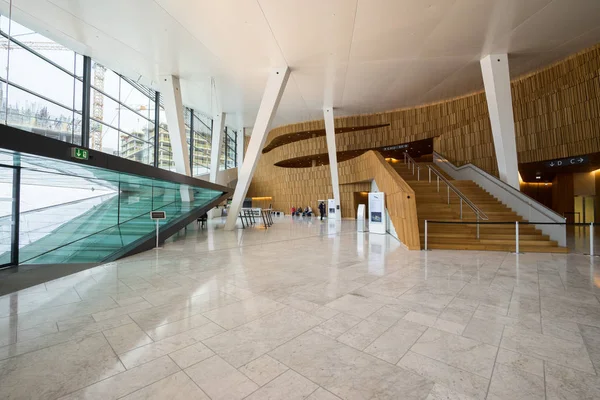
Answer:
[{"left": 0, "top": 150, "right": 223, "bottom": 264}]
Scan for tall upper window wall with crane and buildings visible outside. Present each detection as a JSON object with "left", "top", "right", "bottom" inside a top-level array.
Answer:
[{"left": 0, "top": 15, "right": 237, "bottom": 176}]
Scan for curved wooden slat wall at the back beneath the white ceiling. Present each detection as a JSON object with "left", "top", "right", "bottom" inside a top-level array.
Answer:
[{"left": 250, "top": 42, "right": 600, "bottom": 223}]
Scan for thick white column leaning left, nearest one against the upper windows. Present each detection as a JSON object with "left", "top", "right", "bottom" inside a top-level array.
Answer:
[{"left": 155, "top": 75, "right": 193, "bottom": 202}]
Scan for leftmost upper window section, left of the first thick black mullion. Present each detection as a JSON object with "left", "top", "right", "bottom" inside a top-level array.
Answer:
[{"left": 0, "top": 15, "right": 83, "bottom": 144}]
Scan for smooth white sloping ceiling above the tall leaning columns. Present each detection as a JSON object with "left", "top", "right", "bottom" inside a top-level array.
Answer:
[{"left": 0, "top": 0, "right": 600, "bottom": 126}]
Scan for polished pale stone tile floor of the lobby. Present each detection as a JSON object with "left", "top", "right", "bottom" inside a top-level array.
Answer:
[{"left": 0, "top": 217, "right": 600, "bottom": 400}]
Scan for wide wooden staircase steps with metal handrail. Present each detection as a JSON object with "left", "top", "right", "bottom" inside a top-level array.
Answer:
[{"left": 390, "top": 162, "right": 567, "bottom": 253}]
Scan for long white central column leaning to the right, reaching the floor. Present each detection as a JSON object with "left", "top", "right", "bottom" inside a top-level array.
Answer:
[{"left": 225, "top": 67, "right": 290, "bottom": 230}]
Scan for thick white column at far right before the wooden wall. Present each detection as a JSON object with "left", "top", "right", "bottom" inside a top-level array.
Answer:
[{"left": 481, "top": 54, "right": 520, "bottom": 190}]
